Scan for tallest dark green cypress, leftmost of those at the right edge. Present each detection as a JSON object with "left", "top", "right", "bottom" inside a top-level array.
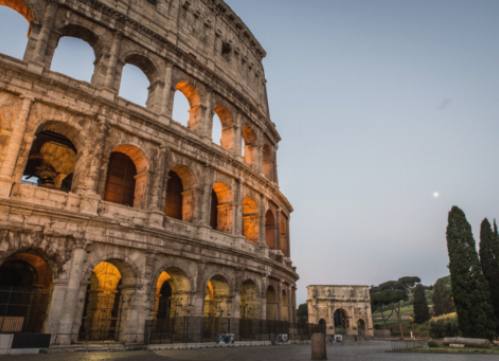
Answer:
[{"left": 447, "top": 207, "right": 495, "bottom": 339}]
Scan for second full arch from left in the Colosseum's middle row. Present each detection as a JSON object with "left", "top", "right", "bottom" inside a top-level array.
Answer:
[{"left": 103, "top": 145, "right": 148, "bottom": 208}]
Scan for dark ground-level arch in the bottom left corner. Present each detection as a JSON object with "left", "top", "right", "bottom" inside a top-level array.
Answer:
[{"left": 0, "top": 252, "right": 52, "bottom": 333}]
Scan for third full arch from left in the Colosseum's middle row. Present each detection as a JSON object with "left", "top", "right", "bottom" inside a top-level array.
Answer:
[{"left": 165, "top": 165, "right": 194, "bottom": 222}]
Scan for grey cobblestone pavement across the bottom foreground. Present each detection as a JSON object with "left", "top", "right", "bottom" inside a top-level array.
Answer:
[{"left": 0, "top": 342, "right": 499, "bottom": 361}]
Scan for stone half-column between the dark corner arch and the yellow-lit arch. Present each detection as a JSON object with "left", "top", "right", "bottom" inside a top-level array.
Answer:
[{"left": 54, "top": 248, "right": 87, "bottom": 345}]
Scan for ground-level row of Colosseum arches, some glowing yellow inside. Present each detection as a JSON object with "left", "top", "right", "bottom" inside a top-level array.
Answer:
[{"left": 0, "top": 250, "right": 292, "bottom": 341}]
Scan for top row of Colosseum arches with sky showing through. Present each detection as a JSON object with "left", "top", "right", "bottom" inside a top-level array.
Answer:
[{"left": 0, "top": 4, "right": 277, "bottom": 181}]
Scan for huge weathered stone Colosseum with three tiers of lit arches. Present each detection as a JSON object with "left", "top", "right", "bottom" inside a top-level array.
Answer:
[{"left": 0, "top": 0, "right": 298, "bottom": 345}]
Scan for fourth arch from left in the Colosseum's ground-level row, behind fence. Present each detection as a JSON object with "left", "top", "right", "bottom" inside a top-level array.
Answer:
[{"left": 203, "top": 276, "right": 231, "bottom": 318}]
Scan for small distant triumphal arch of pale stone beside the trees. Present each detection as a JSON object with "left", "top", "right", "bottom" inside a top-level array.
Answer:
[{"left": 307, "top": 285, "right": 374, "bottom": 337}]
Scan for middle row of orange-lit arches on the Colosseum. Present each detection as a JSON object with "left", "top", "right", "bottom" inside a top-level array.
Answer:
[{"left": 22, "top": 122, "right": 289, "bottom": 254}]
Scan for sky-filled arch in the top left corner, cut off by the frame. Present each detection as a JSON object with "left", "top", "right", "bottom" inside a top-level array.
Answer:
[{"left": 0, "top": 0, "right": 33, "bottom": 60}]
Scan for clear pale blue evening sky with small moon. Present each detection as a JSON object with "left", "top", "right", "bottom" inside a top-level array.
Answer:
[{"left": 0, "top": 0, "right": 499, "bottom": 302}]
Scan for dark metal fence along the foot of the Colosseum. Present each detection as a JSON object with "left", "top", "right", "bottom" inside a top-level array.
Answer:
[{"left": 145, "top": 317, "right": 318, "bottom": 344}]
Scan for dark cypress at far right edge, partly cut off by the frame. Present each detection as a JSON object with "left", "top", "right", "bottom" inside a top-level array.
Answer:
[{"left": 480, "top": 219, "right": 499, "bottom": 331}]
